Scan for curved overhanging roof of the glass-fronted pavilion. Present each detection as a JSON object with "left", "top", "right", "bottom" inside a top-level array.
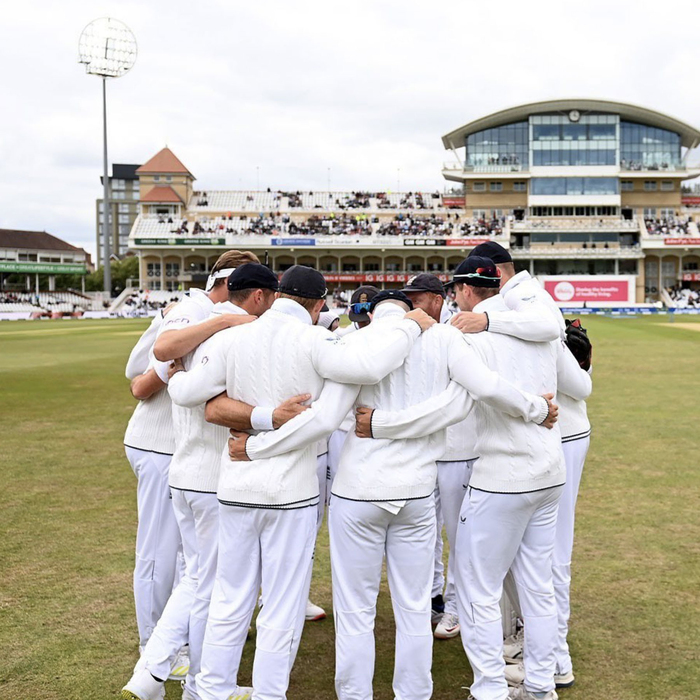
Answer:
[{"left": 442, "top": 99, "right": 700, "bottom": 148}]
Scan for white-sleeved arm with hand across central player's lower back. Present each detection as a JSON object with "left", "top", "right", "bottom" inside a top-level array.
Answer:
[{"left": 355, "top": 382, "right": 474, "bottom": 440}]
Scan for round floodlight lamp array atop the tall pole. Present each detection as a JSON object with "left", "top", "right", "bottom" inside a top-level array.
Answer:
[{"left": 79, "top": 17, "right": 137, "bottom": 78}]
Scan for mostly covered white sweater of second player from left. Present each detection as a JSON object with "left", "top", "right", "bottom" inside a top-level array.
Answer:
[{"left": 170, "top": 301, "right": 247, "bottom": 493}]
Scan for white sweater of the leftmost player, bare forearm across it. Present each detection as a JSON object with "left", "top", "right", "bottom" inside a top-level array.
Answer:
[{"left": 124, "top": 313, "right": 175, "bottom": 455}]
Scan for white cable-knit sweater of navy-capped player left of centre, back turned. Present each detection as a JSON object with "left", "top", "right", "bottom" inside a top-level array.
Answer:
[{"left": 169, "top": 299, "right": 420, "bottom": 508}]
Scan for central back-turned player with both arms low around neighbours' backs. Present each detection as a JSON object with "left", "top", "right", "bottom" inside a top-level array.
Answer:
[{"left": 234, "top": 291, "right": 549, "bottom": 700}]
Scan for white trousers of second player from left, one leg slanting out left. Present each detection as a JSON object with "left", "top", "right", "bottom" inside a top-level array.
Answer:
[{"left": 139, "top": 489, "right": 219, "bottom": 693}]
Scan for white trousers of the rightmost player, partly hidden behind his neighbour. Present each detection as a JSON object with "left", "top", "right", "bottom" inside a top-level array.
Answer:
[{"left": 552, "top": 436, "right": 591, "bottom": 674}]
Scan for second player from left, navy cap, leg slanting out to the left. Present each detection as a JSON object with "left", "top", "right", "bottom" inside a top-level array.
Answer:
[{"left": 122, "top": 263, "right": 290, "bottom": 700}]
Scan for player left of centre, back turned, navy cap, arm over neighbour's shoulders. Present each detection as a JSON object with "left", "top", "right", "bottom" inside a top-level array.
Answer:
[{"left": 169, "top": 265, "right": 432, "bottom": 700}]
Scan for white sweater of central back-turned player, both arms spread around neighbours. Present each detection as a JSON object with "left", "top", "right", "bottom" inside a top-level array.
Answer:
[{"left": 241, "top": 304, "right": 547, "bottom": 502}]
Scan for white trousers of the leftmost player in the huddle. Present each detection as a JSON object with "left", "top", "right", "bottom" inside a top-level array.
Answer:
[{"left": 125, "top": 447, "right": 180, "bottom": 647}]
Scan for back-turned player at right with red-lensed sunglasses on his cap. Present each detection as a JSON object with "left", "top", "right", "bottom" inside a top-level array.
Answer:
[{"left": 446, "top": 256, "right": 591, "bottom": 700}]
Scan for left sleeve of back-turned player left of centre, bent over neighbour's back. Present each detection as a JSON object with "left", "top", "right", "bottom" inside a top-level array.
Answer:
[{"left": 168, "top": 330, "right": 230, "bottom": 408}]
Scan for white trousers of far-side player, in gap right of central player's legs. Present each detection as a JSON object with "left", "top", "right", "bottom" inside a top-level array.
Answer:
[{"left": 432, "top": 459, "right": 476, "bottom": 615}]
